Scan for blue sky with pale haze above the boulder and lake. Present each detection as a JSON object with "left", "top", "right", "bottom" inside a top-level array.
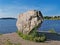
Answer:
[{"left": 0, "top": 0, "right": 60, "bottom": 17}]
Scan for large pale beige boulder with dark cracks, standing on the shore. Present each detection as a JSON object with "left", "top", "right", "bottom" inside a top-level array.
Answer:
[{"left": 16, "top": 10, "right": 43, "bottom": 34}]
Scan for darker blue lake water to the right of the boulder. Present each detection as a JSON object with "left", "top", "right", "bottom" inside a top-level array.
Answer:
[{"left": 39, "top": 20, "right": 60, "bottom": 33}]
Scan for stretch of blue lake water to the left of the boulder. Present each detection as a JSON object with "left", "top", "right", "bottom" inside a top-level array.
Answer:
[{"left": 0, "top": 19, "right": 17, "bottom": 33}]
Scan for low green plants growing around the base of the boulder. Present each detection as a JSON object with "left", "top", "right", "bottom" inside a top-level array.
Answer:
[{"left": 18, "top": 32, "right": 46, "bottom": 42}]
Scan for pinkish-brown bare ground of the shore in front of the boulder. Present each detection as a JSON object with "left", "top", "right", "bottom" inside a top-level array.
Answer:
[{"left": 0, "top": 32, "right": 60, "bottom": 45}]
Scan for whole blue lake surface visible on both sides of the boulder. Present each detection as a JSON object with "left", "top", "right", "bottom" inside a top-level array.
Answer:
[{"left": 0, "top": 19, "right": 60, "bottom": 33}]
